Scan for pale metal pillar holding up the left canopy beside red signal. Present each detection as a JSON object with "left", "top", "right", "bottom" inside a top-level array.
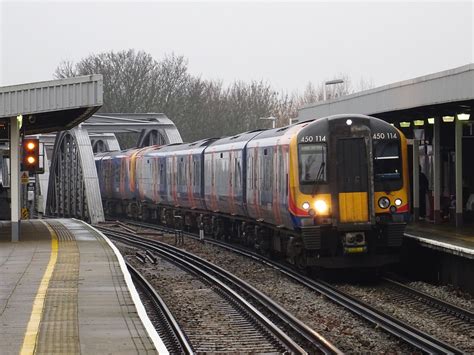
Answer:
[{"left": 10, "top": 117, "right": 20, "bottom": 242}]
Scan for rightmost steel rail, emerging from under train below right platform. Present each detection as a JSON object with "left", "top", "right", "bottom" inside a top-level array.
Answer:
[{"left": 383, "top": 277, "right": 474, "bottom": 323}]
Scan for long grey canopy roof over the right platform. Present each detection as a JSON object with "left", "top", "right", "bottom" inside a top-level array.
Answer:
[{"left": 298, "top": 64, "right": 474, "bottom": 125}]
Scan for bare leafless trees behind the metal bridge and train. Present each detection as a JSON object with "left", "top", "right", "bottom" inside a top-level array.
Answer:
[{"left": 54, "top": 50, "right": 371, "bottom": 141}]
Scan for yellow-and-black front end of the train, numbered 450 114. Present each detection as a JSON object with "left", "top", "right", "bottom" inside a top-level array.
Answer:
[{"left": 290, "top": 115, "right": 408, "bottom": 268}]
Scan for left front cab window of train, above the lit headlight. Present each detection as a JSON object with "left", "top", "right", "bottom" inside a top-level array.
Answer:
[{"left": 299, "top": 143, "right": 327, "bottom": 184}]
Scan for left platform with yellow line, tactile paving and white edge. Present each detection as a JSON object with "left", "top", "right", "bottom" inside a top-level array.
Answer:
[{"left": 0, "top": 219, "right": 167, "bottom": 354}]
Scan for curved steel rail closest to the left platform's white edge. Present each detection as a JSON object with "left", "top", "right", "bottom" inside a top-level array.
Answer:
[{"left": 126, "top": 262, "right": 194, "bottom": 354}]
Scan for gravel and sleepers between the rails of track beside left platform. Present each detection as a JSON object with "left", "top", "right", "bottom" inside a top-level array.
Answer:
[{"left": 117, "top": 243, "right": 281, "bottom": 353}]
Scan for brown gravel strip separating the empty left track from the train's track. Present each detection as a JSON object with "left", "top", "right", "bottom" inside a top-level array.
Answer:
[{"left": 131, "top": 235, "right": 416, "bottom": 353}]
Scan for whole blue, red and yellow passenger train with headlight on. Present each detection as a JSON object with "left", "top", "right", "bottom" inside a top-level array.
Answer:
[{"left": 95, "top": 114, "right": 409, "bottom": 269}]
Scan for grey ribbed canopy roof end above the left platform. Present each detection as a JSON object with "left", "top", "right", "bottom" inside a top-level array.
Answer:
[{"left": 0, "top": 74, "right": 103, "bottom": 134}]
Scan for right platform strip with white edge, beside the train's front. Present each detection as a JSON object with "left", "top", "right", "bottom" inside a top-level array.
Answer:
[{"left": 405, "top": 222, "right": 474, "bottom": 259}]
